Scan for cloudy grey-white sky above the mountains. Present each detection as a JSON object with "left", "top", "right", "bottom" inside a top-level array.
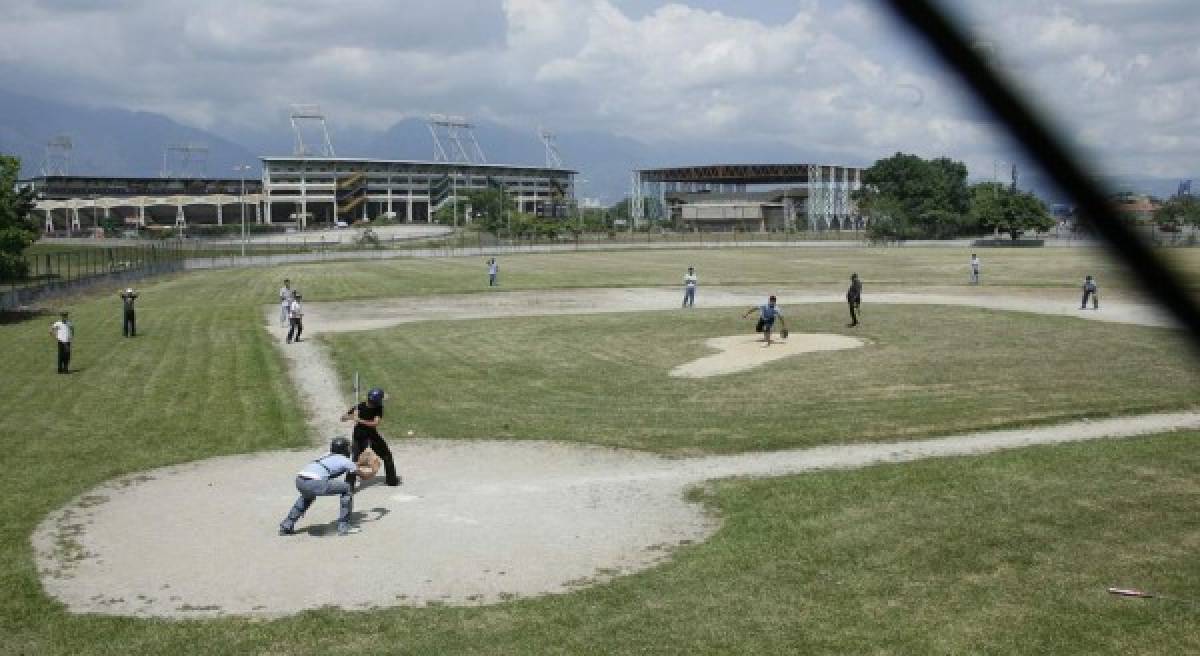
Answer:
[{"left": 0, "top": 0, "right": 1200, "bottom": 184}]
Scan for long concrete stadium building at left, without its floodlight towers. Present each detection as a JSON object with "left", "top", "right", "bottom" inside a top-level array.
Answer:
[{"left": 19, "top": 156, "right": 576, "bottom": 234}]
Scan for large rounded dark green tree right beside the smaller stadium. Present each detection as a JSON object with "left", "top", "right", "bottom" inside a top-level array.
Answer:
[{"left": 854, "top": 152, "right": 971, "bottom": 239}]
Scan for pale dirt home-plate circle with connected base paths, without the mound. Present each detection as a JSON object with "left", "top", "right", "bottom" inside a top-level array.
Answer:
[{"left": 32, "top": 289, "right": 1200, "bottom": 618}]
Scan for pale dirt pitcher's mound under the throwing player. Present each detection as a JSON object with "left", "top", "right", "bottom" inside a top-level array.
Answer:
[{"left": 671, "top": 332, "right": 866, "bottom": 378}]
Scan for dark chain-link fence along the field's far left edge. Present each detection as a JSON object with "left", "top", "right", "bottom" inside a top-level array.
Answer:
[{"left": 0, "top": 242, "right": 184, "bottom": 311}]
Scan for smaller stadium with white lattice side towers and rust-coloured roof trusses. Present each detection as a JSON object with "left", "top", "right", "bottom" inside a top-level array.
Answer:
[{"left": 632, "top": 164, "right": 863, "bottom": 231}]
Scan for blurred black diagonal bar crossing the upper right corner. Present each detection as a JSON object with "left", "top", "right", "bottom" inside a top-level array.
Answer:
[{"left": 887, "top": 0, "right": 1200, "bottom": 349}]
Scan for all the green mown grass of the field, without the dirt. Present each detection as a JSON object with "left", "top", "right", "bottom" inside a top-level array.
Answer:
[{"left": 0, "top": 248, "right": 1200, "bottom": 655}]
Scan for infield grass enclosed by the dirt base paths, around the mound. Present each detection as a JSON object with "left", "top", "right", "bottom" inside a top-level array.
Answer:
[{"left": 325, "top": 305, "right": 1200, "bottom": 455}]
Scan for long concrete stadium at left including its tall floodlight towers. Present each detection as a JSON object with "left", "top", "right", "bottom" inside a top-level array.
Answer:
[{"left": 20, "top": 106, "right": 577, "bottom": 235}]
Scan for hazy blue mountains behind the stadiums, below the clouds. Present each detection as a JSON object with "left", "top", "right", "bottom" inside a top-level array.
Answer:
[{"left": 0, "top": 89, "right": 1178, "bottom": 204}]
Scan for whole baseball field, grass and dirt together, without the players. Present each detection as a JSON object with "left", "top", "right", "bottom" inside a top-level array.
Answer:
[{"left": 0, "top": 247, "right": 1200, "bottom": 655}]
